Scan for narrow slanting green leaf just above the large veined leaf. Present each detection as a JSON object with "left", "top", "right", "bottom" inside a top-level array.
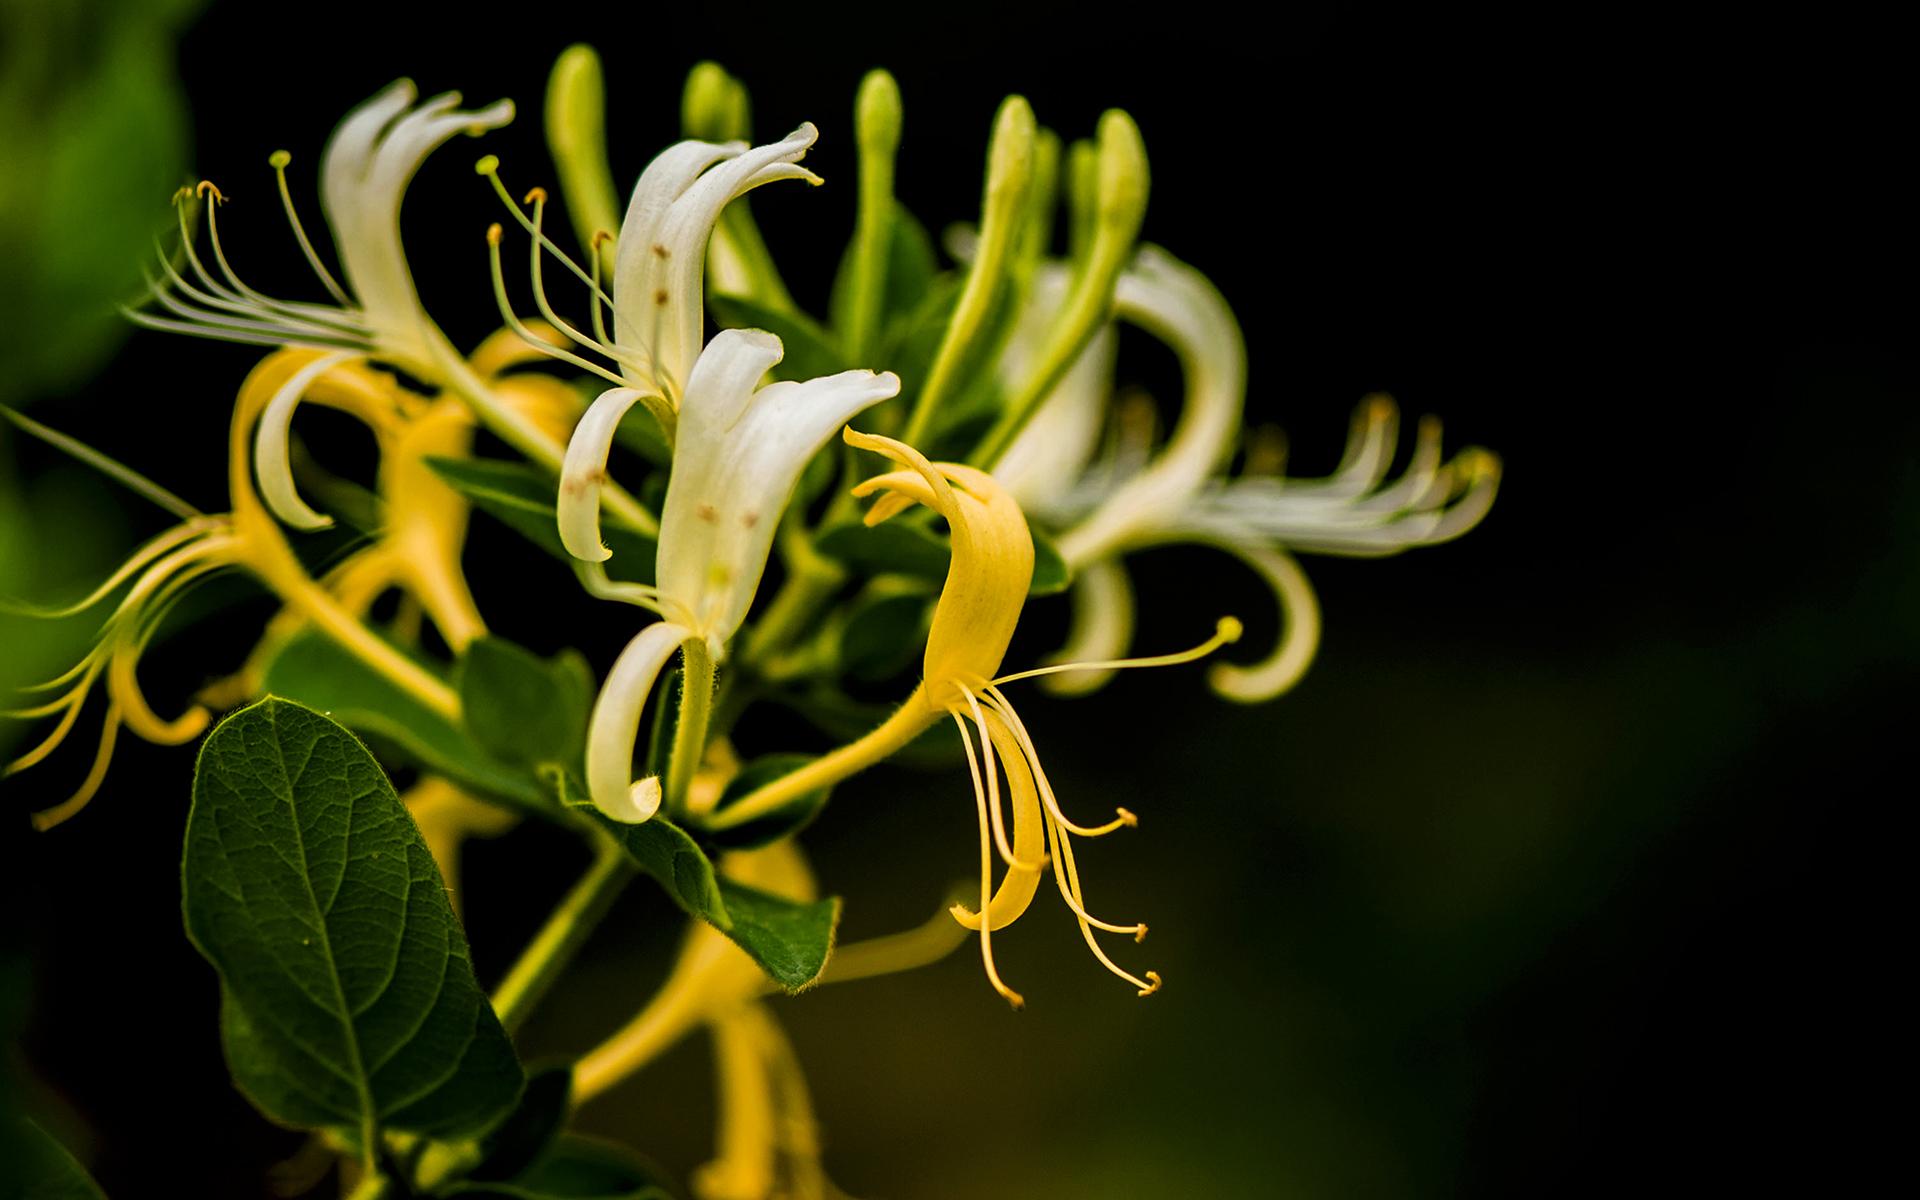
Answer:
[{"left": 265, "top": 630, "right": 553, "bottom": 816}]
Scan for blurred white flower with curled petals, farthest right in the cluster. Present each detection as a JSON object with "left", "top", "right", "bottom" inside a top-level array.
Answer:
[{"left": 995, "top": 246, "right": 1500, "bottom": 703}]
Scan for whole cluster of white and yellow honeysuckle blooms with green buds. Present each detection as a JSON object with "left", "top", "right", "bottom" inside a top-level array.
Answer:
[{"left": 10, "top": 48, "right": 1498, "bottom": 1190}]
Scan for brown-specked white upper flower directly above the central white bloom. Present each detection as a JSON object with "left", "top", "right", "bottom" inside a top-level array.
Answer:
[{"left": 482, "top": 123, "right": 820, "bottom": 413}]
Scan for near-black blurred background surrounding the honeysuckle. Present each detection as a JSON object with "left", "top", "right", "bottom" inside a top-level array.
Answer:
[{"left": 0, "top": 4, "right": 1920, "bottom": 1198}]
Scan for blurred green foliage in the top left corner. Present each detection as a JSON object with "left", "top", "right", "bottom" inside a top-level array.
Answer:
[{"left": 0, "top": 0, "right": 200, "bottom": 405}]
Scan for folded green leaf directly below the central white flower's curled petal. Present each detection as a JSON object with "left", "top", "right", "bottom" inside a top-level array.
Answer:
[{"left": 549, "top": 772, "right": 841, "bottom": 993}]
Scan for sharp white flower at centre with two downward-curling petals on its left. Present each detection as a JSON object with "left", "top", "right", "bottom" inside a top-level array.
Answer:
[{"left": 559, "top": 330, "right": 900, "bottom": 822}]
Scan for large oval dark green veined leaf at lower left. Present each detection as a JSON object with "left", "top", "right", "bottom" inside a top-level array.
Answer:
[{"left": 180, "top": 699, "right": 522, "bottom": 1137}]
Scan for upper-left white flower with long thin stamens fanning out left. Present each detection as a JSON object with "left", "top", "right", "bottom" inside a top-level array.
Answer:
[{"left": 127, "top": 79, "right": 513, "bottom": 530}]
